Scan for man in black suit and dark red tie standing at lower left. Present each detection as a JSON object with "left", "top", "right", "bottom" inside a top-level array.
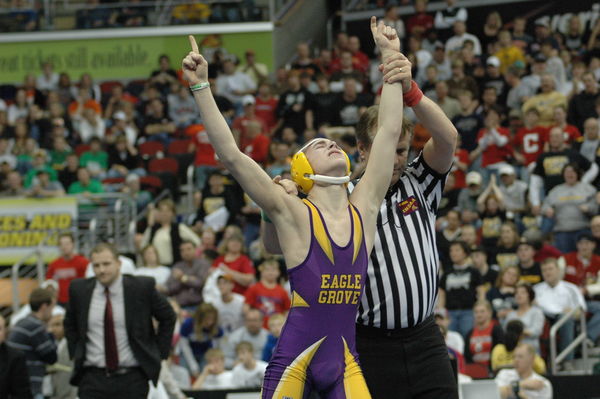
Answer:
[{"left": 65, "top": 244, "right": 175, "bottom": 399}]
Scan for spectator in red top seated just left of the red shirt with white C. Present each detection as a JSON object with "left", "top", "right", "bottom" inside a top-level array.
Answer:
[{"left": 471, "top": 107, "right": 512, "bottom": 169}]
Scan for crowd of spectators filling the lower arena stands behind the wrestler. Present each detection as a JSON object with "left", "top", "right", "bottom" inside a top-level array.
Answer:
[{"left": 0, "top": 0, "right": 600, "bottom": 398}]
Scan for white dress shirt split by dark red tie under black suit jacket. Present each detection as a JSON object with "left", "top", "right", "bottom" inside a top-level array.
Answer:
[{"left": 84, "top": 275, "right": 138, "bottom": 367}]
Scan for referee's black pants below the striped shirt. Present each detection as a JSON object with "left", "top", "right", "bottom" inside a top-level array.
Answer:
[{"left": 356, "top": 316, "right": 458, "bottom": 399}]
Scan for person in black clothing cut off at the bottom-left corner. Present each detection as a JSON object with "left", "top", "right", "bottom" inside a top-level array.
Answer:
[{"left": 0, "top": 315, "right": 33, "bottom": 399}]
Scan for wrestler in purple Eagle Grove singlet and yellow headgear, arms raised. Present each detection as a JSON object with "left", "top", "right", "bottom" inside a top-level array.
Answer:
[{"left": 182, "top": 17, "right": 410, "bottom": 399}]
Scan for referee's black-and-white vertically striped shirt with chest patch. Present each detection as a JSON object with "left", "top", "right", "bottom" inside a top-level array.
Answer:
[{"left": 357, "top": 155, "right": 446, "bottom": 329}]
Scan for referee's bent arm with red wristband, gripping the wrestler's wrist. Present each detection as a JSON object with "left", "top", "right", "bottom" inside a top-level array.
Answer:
[{"left": 383, "top": 54, "right": 458, "bottom": 173}]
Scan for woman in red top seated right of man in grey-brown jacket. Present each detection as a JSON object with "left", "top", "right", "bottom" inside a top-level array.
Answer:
[{"left": 212, "top": 234, "right": 256, "bottom": 295}]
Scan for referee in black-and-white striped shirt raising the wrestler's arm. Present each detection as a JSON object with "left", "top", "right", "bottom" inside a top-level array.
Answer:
[{"left": 263, "top": 54, "right": 458, "bottom": 399}]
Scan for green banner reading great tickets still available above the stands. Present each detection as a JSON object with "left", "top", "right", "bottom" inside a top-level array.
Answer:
[{"left": 0, "top": 32, "right": 273, "bottom": 84}]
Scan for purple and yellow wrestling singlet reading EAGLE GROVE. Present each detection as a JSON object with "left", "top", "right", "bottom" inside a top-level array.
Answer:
[{"left": 262, "top": 200, "right": 371, "bottom": 399}]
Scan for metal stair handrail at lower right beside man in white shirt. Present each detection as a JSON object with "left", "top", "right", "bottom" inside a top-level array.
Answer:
[{"left": 550, "top": 306, "right": 589, "bottom": 375}]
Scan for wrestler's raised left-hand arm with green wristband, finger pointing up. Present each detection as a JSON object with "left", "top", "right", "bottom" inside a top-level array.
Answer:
[{"left": 182, "top": 36, "right": 285, "bottom": 217}]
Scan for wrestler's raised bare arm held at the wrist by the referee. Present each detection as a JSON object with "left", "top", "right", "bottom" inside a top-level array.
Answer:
[{"left": 351, "top": 17, "right": 410, "bottom": 217}]
